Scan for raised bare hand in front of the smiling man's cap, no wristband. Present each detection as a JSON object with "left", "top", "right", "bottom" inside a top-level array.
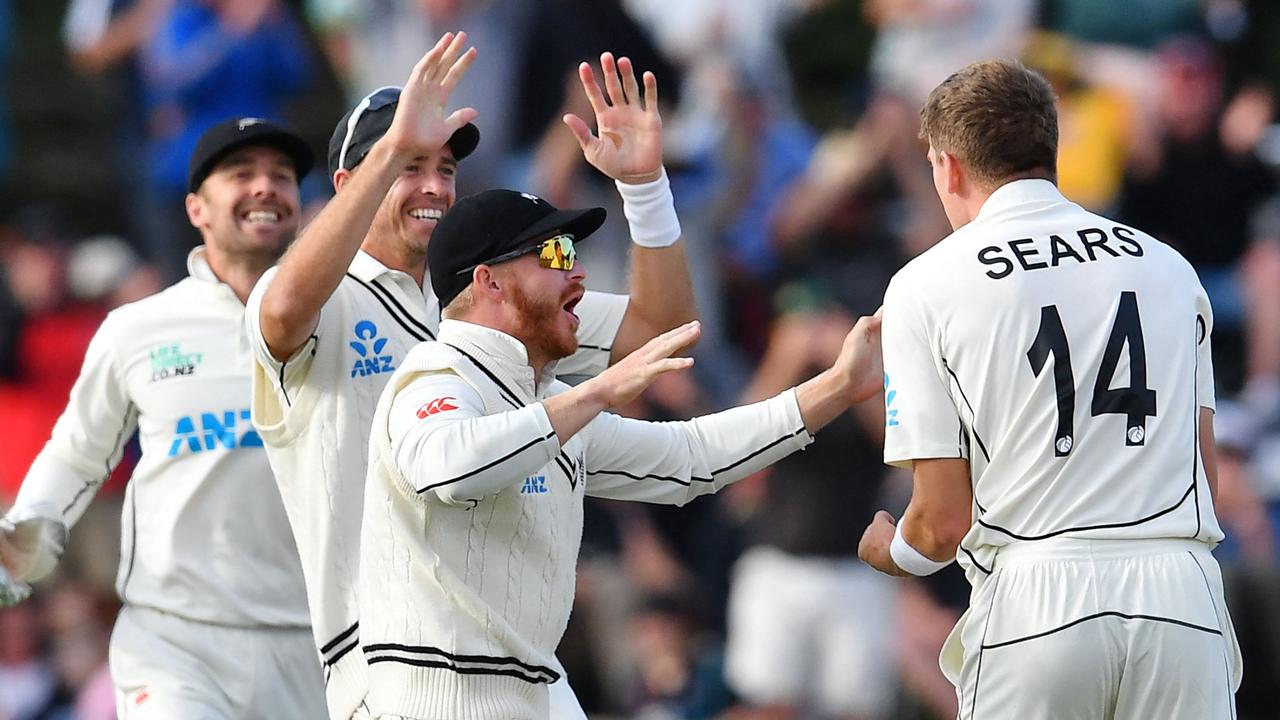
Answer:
[{"left": 387, "top": 32, "right": 479, "bottom": 152}]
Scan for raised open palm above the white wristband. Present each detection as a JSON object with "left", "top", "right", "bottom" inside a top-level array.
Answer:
[{"left": 563, "top": 53, "right": 662, "bottom": 183}]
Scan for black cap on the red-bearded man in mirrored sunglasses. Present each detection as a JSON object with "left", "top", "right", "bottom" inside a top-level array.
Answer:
[{"left": 426, "top": 190, "right": 605, "bottom": 307}]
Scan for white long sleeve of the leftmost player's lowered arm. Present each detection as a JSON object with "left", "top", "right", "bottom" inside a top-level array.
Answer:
[{"left": 8, "top": 312, "right": 137, "bottom": 571}]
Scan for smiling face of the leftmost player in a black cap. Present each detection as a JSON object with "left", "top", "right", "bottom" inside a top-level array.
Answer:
[{"left": 187, "top": 146, "right": 301, "bottom": 258}]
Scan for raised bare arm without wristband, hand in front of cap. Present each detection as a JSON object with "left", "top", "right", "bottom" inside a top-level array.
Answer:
[{"left": 260, "top": 32, "right": 476, "bottom": 361}]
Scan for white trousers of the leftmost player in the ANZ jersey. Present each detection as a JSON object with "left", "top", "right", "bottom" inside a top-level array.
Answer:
[{"left": 110, "top": 605, "right": 329, "bottom": 720}]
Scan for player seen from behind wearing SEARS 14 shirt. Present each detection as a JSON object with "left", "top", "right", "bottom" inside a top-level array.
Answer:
[{"left": 859, "top": 61, "right": 1240, "bottom": 720}]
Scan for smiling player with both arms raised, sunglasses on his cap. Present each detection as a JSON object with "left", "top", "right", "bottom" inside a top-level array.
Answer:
[{"left": 247, "top": 33, "right": 694, "bottom": 719}]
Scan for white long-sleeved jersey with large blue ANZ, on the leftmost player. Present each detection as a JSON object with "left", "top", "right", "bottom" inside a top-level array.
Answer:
[{"left": 10, "top": 247, "right": 311, "bottom": 628}]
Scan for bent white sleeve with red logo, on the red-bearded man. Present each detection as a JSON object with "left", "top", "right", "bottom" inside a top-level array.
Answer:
[{"left": 388, "top": 373, "right": 559, "bottom": 505}]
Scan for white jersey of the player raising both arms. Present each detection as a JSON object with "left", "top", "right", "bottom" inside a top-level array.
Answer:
[{"left": 246, "top": 251, "right": 627, "bottom": 719}]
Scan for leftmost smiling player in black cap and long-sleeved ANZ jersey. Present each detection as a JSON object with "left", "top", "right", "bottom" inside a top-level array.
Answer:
[{"left": 0, "top": 118, "right": 324, "bottom": 720}]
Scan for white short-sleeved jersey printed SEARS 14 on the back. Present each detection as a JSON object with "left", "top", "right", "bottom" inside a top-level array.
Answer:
[{"left": 883, "top": 179, "right": 1222, "bottom": 584}]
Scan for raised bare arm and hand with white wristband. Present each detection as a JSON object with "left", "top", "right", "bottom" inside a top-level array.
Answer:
[{"left": 564, "top": 53, "right": 698, "bottom": 363}]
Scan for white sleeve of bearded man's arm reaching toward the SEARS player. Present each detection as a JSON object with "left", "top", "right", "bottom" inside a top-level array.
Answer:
[{"left": 586, "top": 389, "right": 813, "bottom": 505}]
